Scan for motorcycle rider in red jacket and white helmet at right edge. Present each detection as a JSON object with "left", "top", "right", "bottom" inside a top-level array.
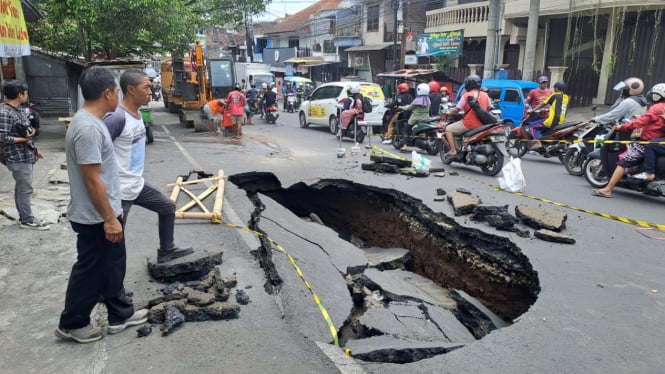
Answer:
[{"left": 591, "top": 83, "right": 665, "bottom": 197}]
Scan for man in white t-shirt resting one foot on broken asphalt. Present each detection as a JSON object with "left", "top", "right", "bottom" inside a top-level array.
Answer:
[{"left": 104, "top": 69, "right": 194, "bottom": 263}]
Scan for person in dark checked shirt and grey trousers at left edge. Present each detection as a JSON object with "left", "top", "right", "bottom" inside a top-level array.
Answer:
[{"left": 0, "top": 79, "right": 49, "bottom": 230}]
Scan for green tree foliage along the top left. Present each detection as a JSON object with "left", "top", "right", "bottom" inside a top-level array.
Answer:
[{"left": 29, "top": 0, "right": 265, "bottom": 58}]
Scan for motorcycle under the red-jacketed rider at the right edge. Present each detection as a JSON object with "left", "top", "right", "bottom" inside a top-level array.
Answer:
[{"left": 582, "top": 131, "right": 665, "bottom": 197}]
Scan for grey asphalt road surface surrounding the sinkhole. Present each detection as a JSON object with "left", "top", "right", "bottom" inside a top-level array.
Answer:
[{"left": 0, "top": 103, "right": 665, "bottom": 374}]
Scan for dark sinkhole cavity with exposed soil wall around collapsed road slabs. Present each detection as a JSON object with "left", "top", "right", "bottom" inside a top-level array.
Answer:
[{"left": 229, "top": 172, "right": 540, "bottom": 362}]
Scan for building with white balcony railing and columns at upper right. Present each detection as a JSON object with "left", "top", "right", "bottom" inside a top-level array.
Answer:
[{"left": 425, "top": 0, "right": 665, "bottom": 105}]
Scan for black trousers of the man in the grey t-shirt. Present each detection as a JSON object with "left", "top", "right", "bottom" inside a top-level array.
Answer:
[{"left": 59, "top": 218, "right": 134, "bottom": 329}]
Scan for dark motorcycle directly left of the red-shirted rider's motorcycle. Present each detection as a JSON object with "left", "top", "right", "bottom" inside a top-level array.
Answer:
[{"left": 393, "top": 116, "right": 443, "bottom": 155}]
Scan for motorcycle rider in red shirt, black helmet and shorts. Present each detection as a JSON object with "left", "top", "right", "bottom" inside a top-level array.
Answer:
[{"left": 445, "top": 74, "right": 492, "bottom": 157}]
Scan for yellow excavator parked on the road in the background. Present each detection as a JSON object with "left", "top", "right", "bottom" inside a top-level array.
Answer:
[{"left": 162, "top": 41, "right": 235, "bottom": 132}]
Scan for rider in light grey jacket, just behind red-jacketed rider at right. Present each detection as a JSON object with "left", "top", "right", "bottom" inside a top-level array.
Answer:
[{"left": 589, "top": 77, "right": 647, "bottom": 124}]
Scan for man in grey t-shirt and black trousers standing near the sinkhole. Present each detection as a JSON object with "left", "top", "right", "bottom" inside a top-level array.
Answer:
[{"left": 55, "top": 66, "right": 148, "bottom": 343}]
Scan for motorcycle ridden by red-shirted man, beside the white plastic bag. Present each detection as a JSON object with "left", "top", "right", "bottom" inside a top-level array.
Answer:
[{"left": 439, "top": 111, "right": 508, "bottom": 176}]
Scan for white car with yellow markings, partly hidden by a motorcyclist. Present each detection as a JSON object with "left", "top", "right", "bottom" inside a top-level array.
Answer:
[{"left": 298, "top": 82, "right": 386, "bottom": 134}]
